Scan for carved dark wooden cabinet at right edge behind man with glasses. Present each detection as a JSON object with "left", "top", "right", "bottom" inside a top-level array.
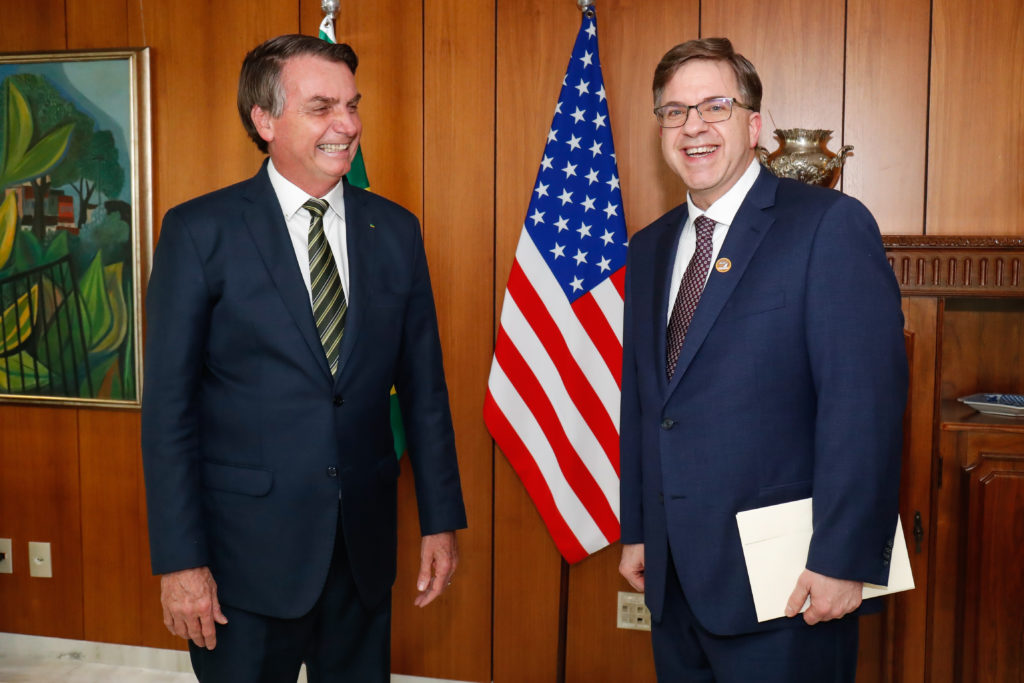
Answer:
[{"left": 858, "top": 238, "right": 1024, "bottom": 683}]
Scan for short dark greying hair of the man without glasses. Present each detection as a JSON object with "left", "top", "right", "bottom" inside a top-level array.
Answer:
[{"left": 239, "top": 34, "right": 359, "bottom": 154}]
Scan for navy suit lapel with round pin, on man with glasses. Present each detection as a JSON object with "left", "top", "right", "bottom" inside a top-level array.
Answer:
[{"left": 662, "top": 169, "right": 778, "bottom": 393}]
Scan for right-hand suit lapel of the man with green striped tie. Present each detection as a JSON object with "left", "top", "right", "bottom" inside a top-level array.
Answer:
[{"left": 338, "top": 181, "right": 377, "bottom": 379}]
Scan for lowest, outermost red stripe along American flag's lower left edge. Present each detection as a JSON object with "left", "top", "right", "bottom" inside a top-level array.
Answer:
[{"left": 483, "top": 391, "right": 588, "bottom": 563}]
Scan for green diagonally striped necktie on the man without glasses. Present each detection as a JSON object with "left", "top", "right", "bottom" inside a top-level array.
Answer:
[{"left": 302, "top": 199, "right": 348, "bottom": 376}]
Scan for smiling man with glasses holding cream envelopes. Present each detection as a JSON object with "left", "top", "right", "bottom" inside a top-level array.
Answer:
[{"left": 620, "top": 39, "right": 907, "bottom": 683}]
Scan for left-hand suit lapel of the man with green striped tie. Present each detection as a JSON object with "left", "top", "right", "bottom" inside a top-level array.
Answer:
[{"left": 242, "top": 163, "right": 331, "bottom": 377}]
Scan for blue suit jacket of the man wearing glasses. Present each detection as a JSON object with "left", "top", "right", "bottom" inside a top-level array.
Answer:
[{"left": 621, "top": 169, "right": 907, "bottom": 635}]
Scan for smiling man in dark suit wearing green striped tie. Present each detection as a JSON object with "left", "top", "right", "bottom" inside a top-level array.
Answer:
[{"left": 142, "top": 35, "right": 466, "bottom": 683}]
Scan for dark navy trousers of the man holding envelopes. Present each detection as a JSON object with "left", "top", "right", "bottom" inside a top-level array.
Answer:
[{"left": 651, "top": 560, "right": 858, "bottom": 683}]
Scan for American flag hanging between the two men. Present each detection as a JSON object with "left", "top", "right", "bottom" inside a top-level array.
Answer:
[{"left": 483, "top": 8, "right": 627, "bottom": 562}]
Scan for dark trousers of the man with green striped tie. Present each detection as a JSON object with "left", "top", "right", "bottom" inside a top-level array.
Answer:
[{"left": 188, "top": 526, "right": 391, "bottom": 683}]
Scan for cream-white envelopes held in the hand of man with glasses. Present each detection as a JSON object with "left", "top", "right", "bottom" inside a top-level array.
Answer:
[{"left": 736, "top": 498, "right": 913, "bottom": 622}]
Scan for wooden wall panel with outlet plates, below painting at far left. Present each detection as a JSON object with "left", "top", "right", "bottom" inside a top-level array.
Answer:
[{"left": 0, "top": 405, "right": 82, "bottom": 638}]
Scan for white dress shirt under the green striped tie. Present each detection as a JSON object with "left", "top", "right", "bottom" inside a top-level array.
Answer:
[{"left": 266, "top": 161, "right": 349, "bottom": 305}]
